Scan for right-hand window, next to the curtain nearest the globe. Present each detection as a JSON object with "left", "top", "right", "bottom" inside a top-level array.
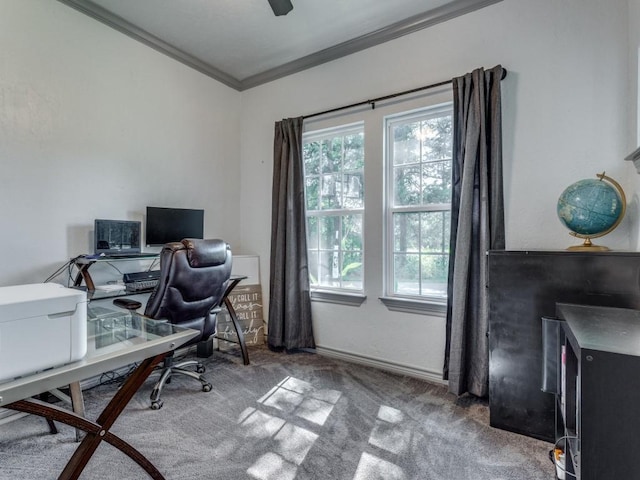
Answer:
[{"left": 385, "top": 104, "right": 453, "bottom": 301}]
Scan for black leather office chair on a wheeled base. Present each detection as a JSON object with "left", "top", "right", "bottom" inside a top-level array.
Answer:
[{"left": 138, "top": 239, "right": 232, "bottom": 410}]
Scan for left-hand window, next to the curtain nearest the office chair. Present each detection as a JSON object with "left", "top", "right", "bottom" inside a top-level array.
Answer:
[{"left": 303, "top": 123, "right": 364, "bottom": 291}]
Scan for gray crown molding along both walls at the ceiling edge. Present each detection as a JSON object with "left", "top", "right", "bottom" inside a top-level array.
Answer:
[{"left": 58, "top": 0, "right": 503, "bottom": 91}]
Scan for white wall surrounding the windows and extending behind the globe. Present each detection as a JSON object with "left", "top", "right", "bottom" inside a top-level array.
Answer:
[{"left": 241, "top": 0, "right": 635, "bottom": 376}]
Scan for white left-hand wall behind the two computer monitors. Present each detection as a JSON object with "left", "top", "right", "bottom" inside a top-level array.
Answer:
[{"left": 0, "top": 0, "right": 240, "bottom": 285}]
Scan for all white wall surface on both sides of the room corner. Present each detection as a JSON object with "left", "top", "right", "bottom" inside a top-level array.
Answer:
[{"left": 0, "top": 0, "right": 640, "bottom": 377}]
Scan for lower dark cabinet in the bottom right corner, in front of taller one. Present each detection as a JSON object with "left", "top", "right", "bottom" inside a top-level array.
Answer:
[{"left": 556, "top": 304, "right": 640, "bottom": 480}]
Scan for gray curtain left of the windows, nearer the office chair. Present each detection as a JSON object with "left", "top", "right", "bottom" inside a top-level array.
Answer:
[{"left": 267, "top": 117, "right": 315, "bottom": 350}]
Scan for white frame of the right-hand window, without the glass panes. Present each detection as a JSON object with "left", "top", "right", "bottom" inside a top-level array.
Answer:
[{"left": 380, "top": 101, "right": 454, "bottom": 308}]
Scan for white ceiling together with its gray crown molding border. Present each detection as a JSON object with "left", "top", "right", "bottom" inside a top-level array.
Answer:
[{"left": 59, "top": 0, "right": 502, "bottom": 91}]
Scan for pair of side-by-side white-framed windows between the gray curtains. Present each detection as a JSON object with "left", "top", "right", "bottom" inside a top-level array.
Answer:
[{"left": 303, "top": 95, "right": 453, "bottom": 316}]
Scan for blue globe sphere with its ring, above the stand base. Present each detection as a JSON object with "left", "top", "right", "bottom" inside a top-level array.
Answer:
[{"left": 558, "top": 174, "right": 624, "bottom": 237}]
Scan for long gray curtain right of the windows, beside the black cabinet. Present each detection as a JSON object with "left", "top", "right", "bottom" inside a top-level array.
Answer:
[{"left": 444, "top": 65, "right": 505, "bottom": 397}]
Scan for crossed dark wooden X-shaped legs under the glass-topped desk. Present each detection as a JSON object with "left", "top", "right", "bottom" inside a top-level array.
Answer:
[{"left": 5, "top": 353, "right": 167, "bottom": 480}]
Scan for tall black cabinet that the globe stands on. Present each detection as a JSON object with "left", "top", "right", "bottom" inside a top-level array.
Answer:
[{"left": 487, "top": 251, "right": 640, "bottom": 442}]
